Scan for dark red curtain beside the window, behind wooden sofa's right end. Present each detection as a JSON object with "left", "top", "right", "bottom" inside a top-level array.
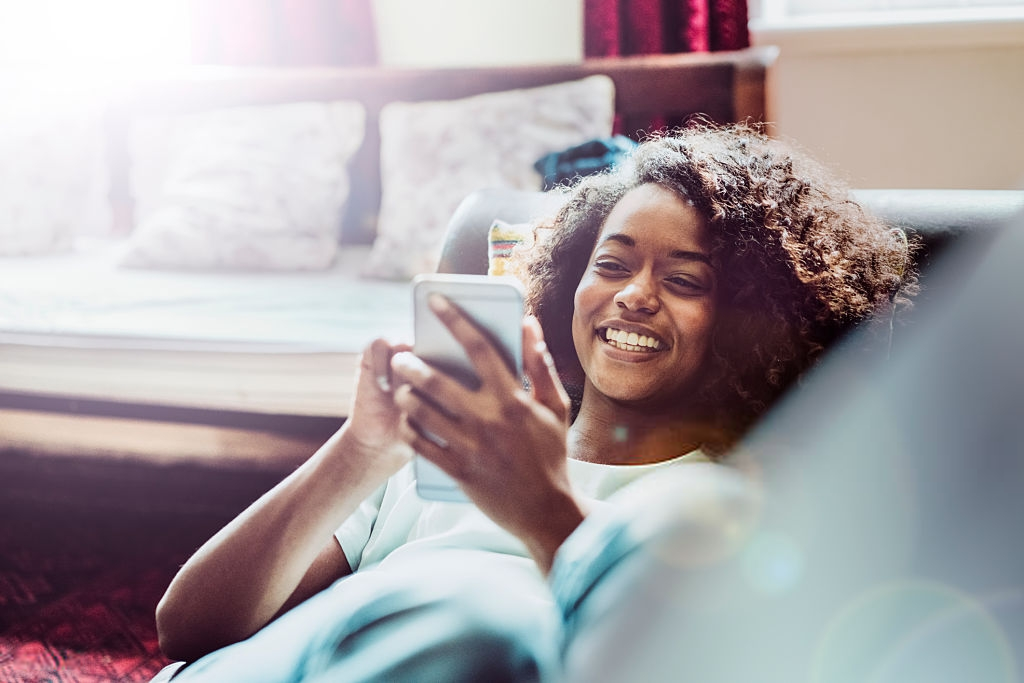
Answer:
[{"left": 584, "top": 0, "right": 750, "bottom": 57}]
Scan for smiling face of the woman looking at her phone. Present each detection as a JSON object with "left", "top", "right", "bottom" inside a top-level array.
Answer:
[{"left": 572, "top": 184, "right": 717, "bottom": 404}]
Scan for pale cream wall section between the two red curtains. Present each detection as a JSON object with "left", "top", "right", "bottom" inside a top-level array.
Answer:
[{"left": 374, "top": 0, "right": 583, "bottom": 67}]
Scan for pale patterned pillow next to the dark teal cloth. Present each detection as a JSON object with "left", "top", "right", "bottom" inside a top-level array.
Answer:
[{"left": 364, "top": 76, "right": 614, "bottom": 280}]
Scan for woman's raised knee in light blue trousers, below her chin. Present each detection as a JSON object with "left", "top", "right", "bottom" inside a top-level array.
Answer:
[{"left": 550, "top": 463, "right": 762, "bottom": 683}]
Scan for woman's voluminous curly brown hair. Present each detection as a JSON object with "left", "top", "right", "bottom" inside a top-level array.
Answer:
[{"left": 524, "top": 122, "right": 916, "bottom": 451}]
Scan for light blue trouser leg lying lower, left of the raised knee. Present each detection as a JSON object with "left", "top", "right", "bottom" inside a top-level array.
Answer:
[{"left": 173, "top": 553, "right": 558, "bottom": 683}]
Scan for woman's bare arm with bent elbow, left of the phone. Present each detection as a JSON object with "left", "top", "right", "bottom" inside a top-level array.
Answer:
[{"left": 157, "top": 341, "right": 411, "bottom": 660}]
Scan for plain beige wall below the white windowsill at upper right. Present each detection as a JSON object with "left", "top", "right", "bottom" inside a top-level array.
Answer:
[{"left": 752, "top": 18, "right": 1024, "bottom": 189}]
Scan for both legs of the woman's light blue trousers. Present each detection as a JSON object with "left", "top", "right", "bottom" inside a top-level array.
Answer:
[{"left": 165, "top": 464, "right": 754, "bottom": 683}]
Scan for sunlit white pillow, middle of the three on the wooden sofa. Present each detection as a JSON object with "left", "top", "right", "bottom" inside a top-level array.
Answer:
[{"left": 122, "top": 101, "right": 366, "bottom": 270}]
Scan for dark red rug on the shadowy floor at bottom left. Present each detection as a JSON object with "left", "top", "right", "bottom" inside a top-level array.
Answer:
[{"left": 0, "top": 452, "right": 283, "bottom": 683}]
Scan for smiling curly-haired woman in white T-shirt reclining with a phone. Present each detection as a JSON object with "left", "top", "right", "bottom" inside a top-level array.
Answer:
[{"left": 149, "top": 126, "right": 913, "bottom": 680}]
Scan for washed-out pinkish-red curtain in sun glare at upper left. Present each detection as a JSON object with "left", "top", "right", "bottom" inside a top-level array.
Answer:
[{"left": 191, "top": 0, "right": 377, "bottom": 67}]
